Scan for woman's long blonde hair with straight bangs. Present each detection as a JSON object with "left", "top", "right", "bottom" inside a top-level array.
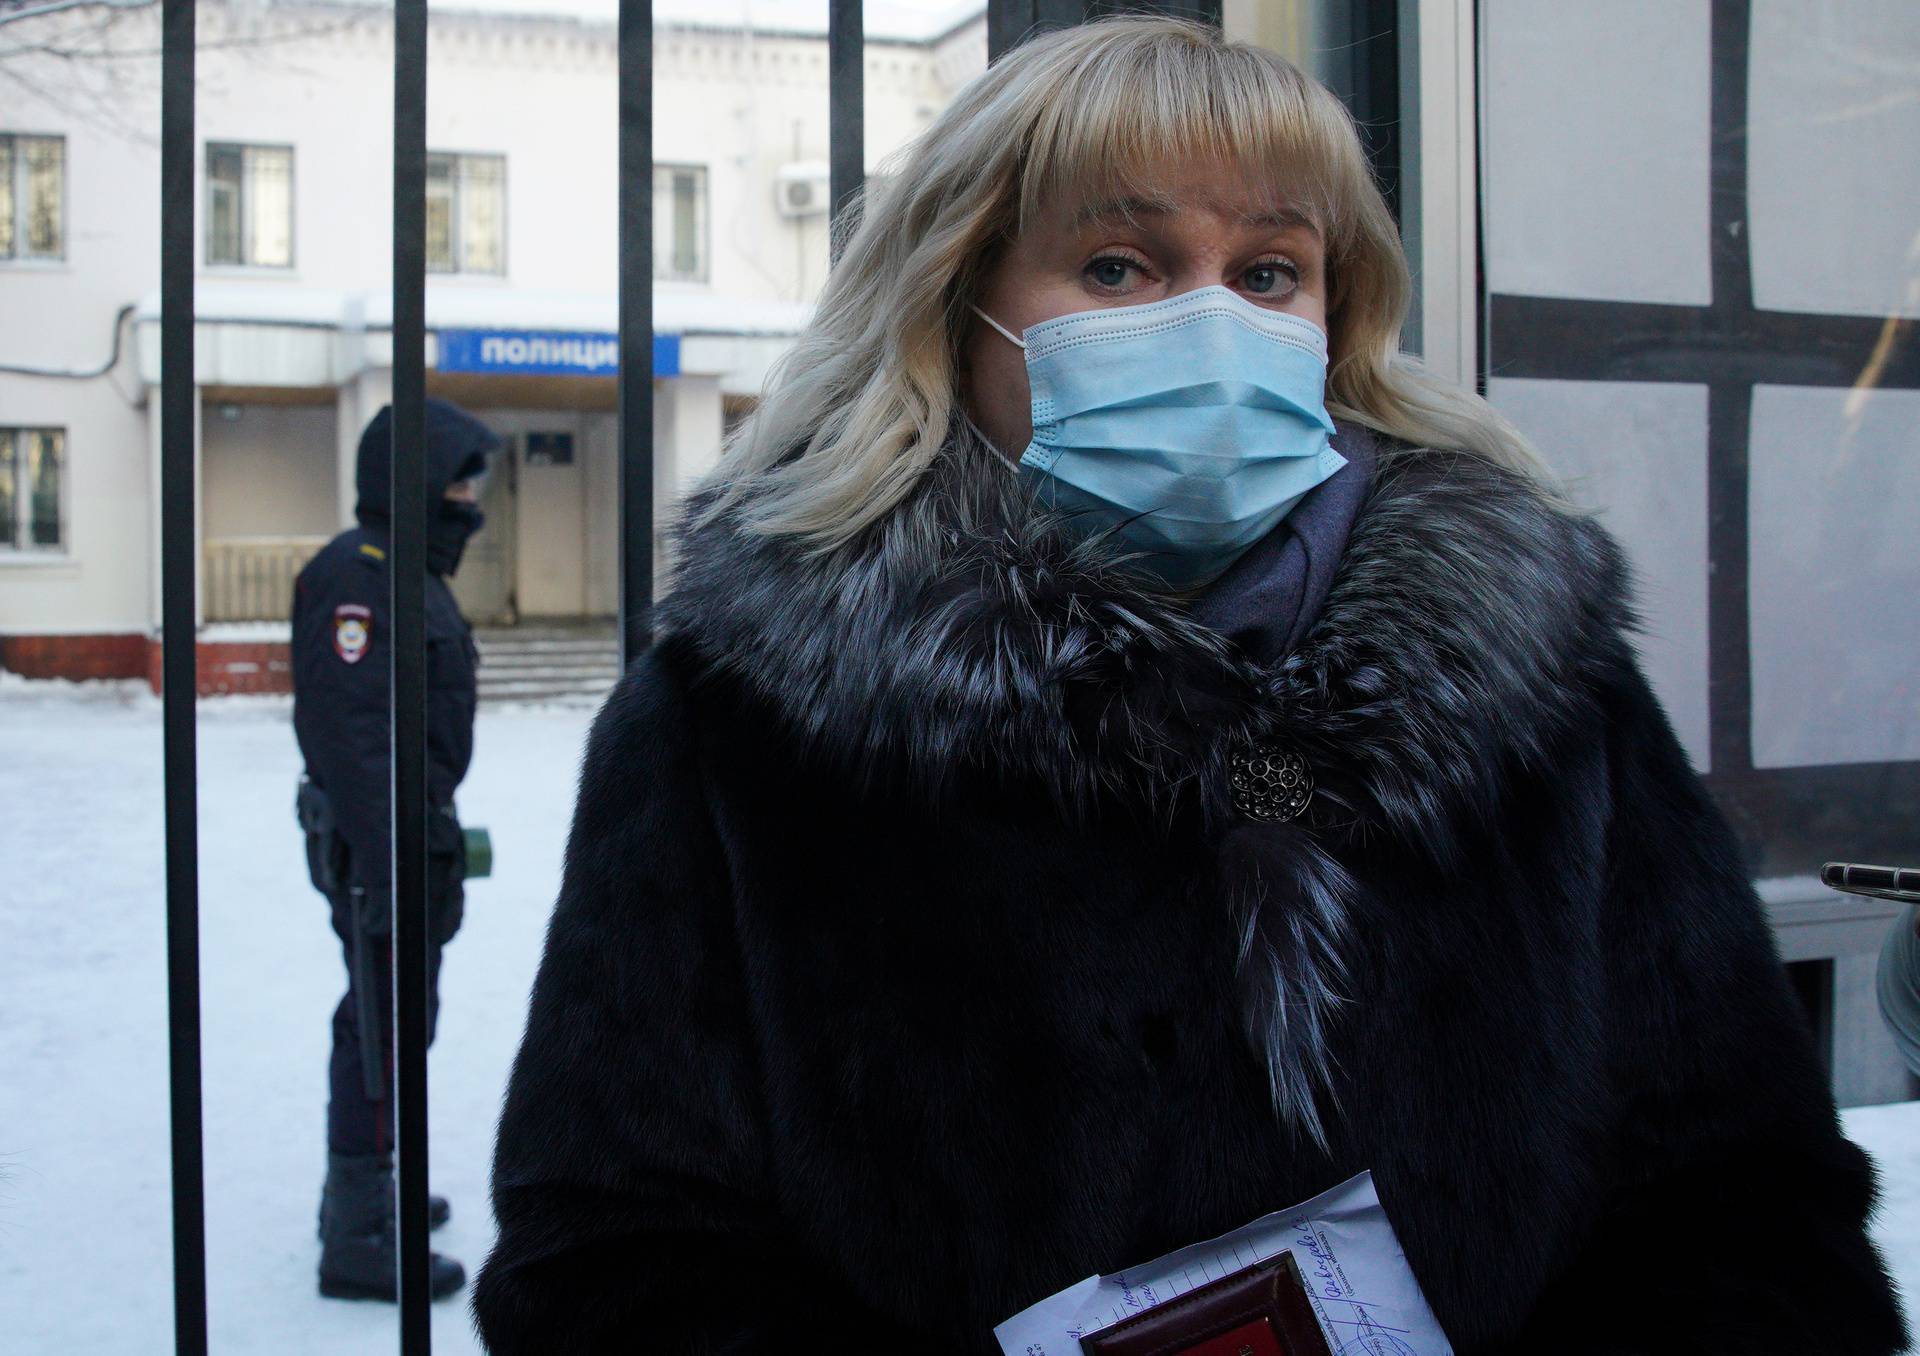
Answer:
[{"left": 699, "top": 17, "right": 1551, "bottom": 549}]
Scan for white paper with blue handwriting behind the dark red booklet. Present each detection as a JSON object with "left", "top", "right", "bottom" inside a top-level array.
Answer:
[{"left": 993, "top": 1172, "right": 1453, "bottom": 1356}]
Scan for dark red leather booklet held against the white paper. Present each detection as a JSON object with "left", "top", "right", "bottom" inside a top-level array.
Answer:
[{"left": 1081, "top": 1252, "right": 1332, "bottom": 1356}]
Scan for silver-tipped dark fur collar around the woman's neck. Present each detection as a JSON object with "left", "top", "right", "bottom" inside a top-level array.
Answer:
[{"left": 657, "top": 421, "right": 1634, "bottom": 857}]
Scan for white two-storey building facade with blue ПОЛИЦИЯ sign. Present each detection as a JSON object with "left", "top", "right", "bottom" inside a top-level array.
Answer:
[{"left": 0, "top": 0, "right": 985, "bottom": 688}]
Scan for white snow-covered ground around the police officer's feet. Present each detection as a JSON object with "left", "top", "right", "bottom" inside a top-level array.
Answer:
[{"left": 0, "top": 676, "right": 1920, "bottom": 1356}]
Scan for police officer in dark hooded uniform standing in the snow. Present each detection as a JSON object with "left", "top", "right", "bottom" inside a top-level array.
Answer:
[{"left": 292, "top": 400, "right": 499, "bottom": 1300}]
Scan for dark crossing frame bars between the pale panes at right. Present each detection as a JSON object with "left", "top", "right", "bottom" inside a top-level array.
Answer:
[{"left": 1475, "top": 0, "right": 1920, "bottom": 878}]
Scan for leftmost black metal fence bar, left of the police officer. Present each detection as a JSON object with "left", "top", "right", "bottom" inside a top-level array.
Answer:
[{"left": 159, "top": 0, "right": 207, "bottom": 1356}]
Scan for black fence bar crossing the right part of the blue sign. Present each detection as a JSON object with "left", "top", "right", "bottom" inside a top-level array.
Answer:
[{"left": 618, "top": 0, "right": 653, "bottom": 668}]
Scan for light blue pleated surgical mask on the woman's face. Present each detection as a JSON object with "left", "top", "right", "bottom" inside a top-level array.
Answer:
[{"left": 973, "top": 286, "right": 1346, "bottom": 590}]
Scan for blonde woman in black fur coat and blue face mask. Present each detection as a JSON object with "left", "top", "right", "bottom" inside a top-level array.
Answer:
[{"left": 474, "top": 19, "right": 1905, "bottom": 1356}]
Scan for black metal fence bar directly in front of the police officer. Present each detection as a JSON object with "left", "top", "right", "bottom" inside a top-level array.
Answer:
[{"left": 388, "top": 0, "right": 438, "bottom": 1356}]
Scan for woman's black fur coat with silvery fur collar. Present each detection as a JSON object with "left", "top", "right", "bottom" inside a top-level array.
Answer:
[{"left": 474, "top": 422, "right": 1903, "bottom": 1356}]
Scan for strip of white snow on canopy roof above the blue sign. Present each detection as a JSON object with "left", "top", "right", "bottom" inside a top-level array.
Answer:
[{"left": 136, "top": 280, "right": 812, "bottom": 334}]
